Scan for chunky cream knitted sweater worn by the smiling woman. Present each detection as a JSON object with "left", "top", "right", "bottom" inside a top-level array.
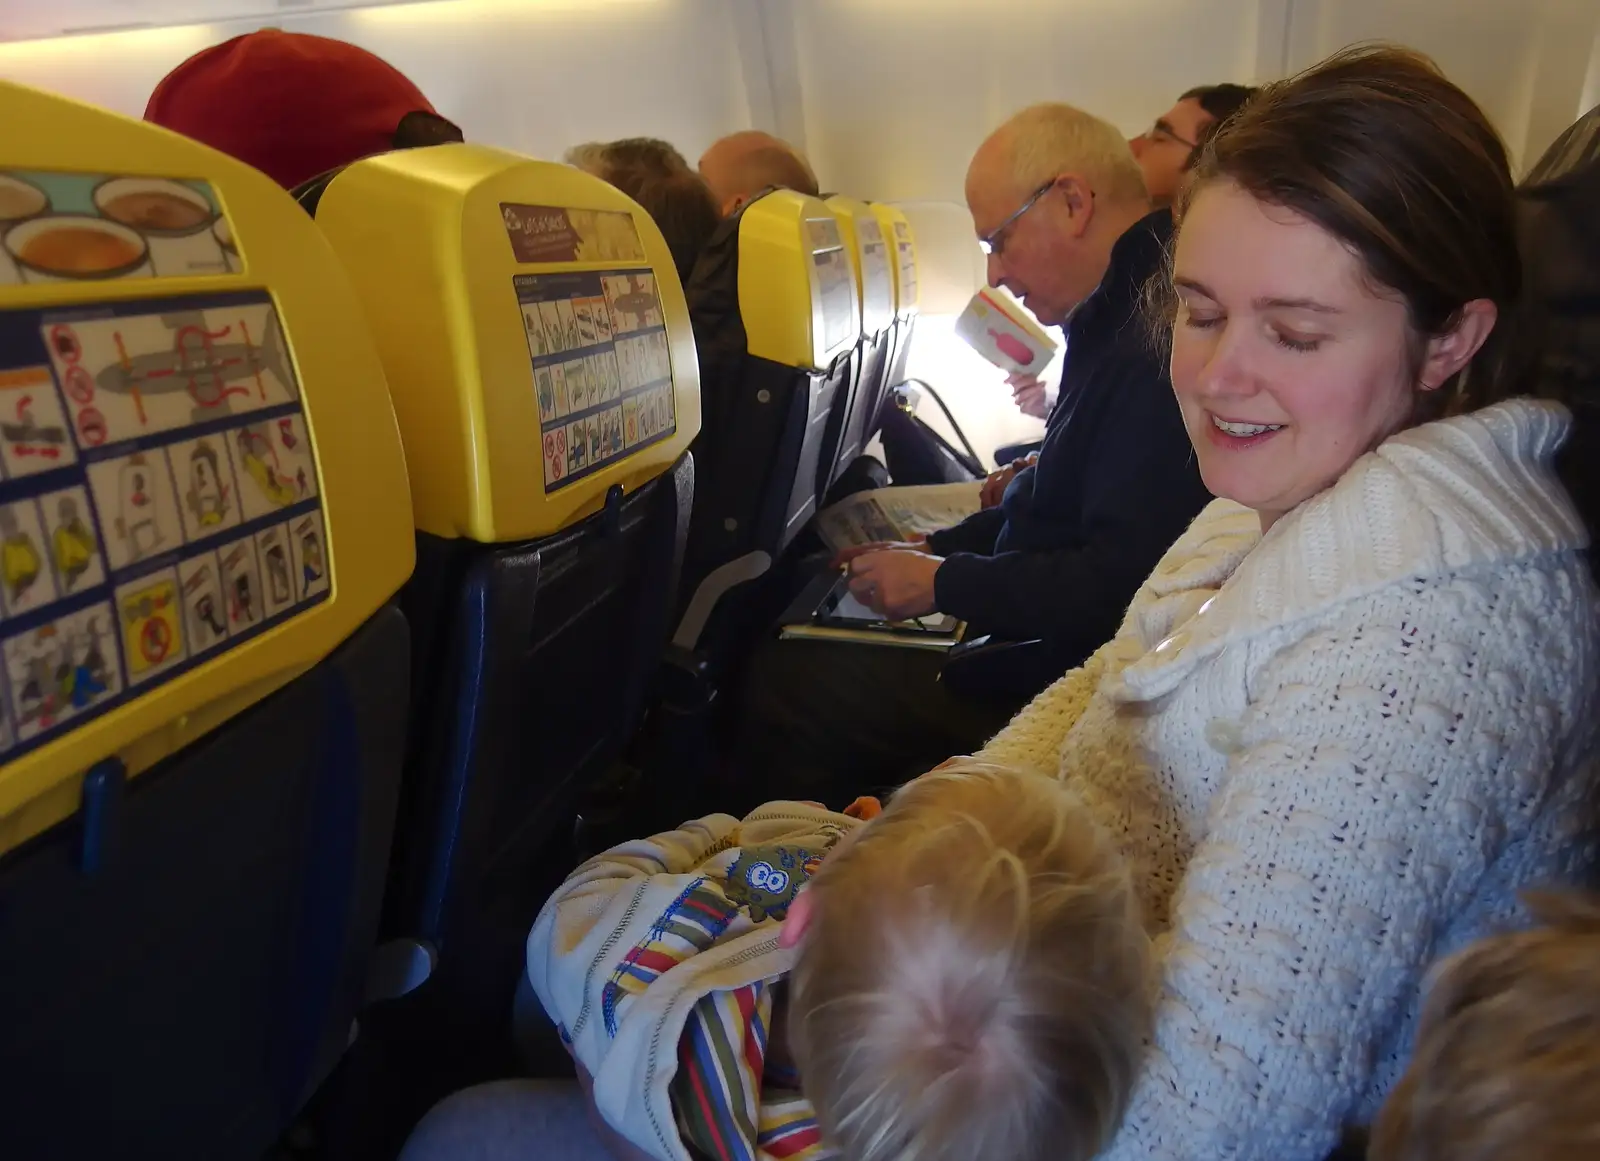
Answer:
[{"left": 982, "top": 400, "right": 1600, "bottom": 1161}]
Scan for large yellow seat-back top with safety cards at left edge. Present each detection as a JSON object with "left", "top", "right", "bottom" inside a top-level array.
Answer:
[{"left": 0, "top": 82, "right": 414, "bottom": 851}]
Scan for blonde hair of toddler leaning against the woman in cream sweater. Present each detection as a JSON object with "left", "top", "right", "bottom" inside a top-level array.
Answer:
[{"left": 789, "top": 760, "right": 1149, "bottom": 1161}]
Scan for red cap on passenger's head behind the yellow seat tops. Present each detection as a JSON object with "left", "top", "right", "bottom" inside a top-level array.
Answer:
[{"left": 144, "top": 29, "right": 461, "bottom": 189}]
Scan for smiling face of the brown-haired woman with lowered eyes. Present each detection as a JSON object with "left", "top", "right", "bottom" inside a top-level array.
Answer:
[{"left": 1171, "top": 181, "right": 1443, "bottom": 528}]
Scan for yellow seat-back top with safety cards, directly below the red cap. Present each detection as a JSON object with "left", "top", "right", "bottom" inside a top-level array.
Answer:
[{"left": 317, "top": 144, "right": 699, "bottom": 544}]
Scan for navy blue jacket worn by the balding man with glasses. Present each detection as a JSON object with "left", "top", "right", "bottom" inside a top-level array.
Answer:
[{"left": 928, "top": 209, "right": 1211, "bottom": 675}]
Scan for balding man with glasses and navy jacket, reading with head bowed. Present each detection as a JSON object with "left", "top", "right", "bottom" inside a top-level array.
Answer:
[{"left": 742, "top": 104, "right": 1210, "bottom": 801}]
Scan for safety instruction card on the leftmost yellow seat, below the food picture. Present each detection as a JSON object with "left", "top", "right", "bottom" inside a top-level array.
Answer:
[{"left": 0, "top": 291, "right": 330, "bottom": 761}]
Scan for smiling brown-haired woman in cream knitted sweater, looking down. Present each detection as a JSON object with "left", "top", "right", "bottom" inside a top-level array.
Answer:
[{"left": 953, "top": 48, "right": 1600, "bottom": 1161}]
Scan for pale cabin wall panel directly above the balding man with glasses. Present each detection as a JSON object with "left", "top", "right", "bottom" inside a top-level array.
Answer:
[{"left": 787, "top": 0, "right": 1277, "bottom": 203}]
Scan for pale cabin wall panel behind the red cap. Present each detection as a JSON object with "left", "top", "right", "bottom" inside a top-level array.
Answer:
[{"left": 0, "top": 0, "right": 752, "bottom": 160}]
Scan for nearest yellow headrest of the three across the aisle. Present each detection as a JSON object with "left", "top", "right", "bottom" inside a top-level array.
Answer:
[{"left": 739, "top": 189, "right": 861, "bottom": 371}]
